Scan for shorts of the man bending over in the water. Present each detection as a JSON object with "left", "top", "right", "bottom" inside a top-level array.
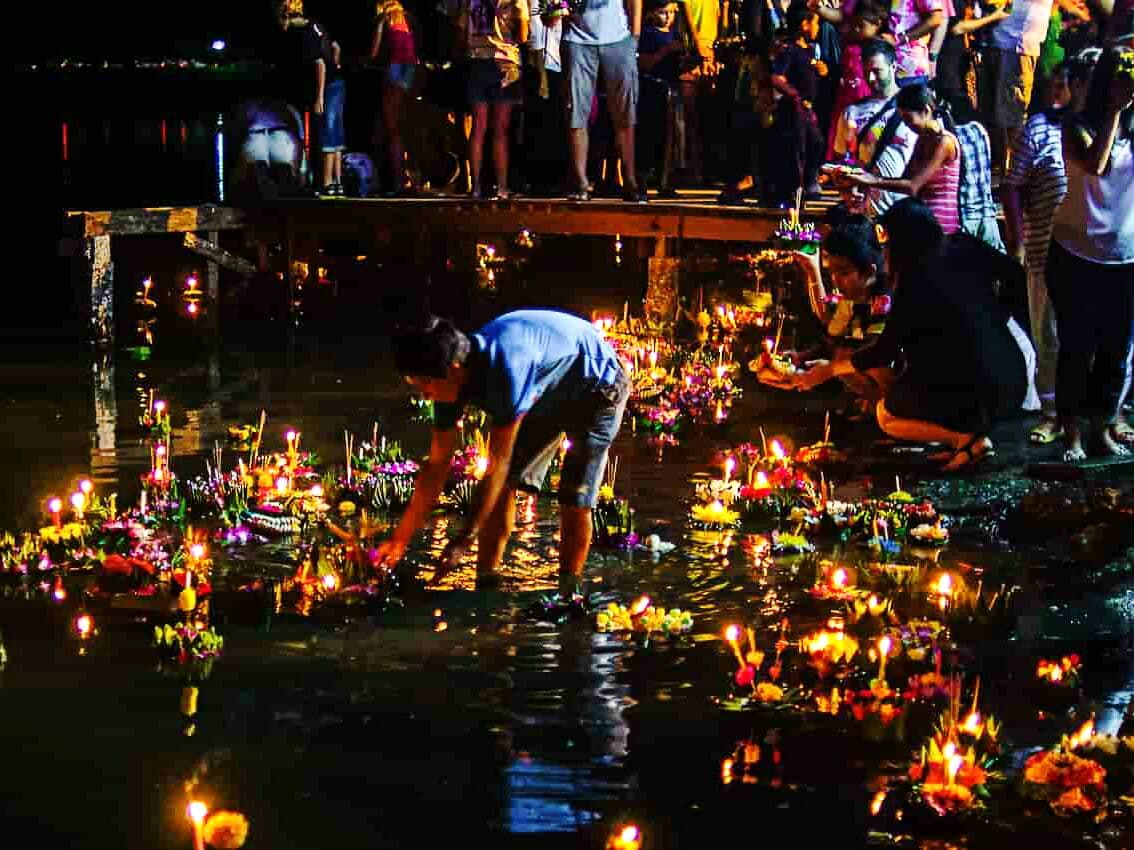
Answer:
[{"left": 508, "top": 373, "right": 631, "bottom": 508}]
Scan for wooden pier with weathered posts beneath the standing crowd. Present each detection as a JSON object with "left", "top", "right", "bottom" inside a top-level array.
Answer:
[{"left": 65, "top": 192, "right": 830, "bottom": 342}]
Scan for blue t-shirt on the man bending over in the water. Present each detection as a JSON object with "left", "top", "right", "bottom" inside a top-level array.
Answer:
[{"left": 433, "top": 309, "right": 621, "bottom": 431}]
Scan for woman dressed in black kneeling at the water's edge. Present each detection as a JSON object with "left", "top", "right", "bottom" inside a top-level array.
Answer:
[{"left": 795, "top": 198, "right": 1027, "bottom": 470}]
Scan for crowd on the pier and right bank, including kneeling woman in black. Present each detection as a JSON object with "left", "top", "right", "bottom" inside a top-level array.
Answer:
[{"left": 247, "top": 0, "right": 1134, "bottom": 468}]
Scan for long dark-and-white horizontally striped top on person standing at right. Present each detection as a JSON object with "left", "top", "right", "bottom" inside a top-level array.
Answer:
[{"left": 1004, "top": 112, "right": 1067, "bottom": 272}]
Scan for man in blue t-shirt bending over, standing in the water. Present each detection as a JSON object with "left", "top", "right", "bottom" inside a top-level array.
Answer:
[{"left": 378, "top": 309, "right": 629, "bottom": 584}]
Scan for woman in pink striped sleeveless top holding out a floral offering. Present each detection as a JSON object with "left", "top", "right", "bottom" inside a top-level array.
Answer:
[{"left": 849, "top": 85, "right": 960, "bottom": 236}]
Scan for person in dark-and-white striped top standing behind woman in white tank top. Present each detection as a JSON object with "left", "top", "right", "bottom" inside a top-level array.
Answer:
[{"left": 1001, "top": 59, "right": 1094, "bottom": 445}]
